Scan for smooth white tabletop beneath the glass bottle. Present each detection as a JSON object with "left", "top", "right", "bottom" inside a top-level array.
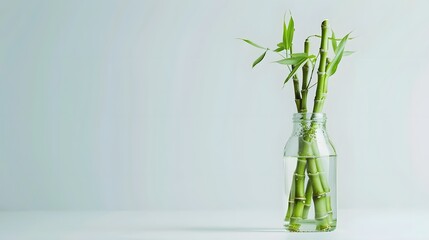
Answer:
[{"left": 0, "top": 209, "right": 429, "bottom": 240}]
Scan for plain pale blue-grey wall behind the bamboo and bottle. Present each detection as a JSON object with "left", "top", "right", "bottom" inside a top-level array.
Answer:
[{"left": 0, "top": 0, "right": 429, "bottom": 215}]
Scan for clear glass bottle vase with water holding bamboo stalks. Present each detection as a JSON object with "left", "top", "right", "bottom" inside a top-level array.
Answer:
[{"left": 284, "top": 113, "right": 337, "bottom": 232}]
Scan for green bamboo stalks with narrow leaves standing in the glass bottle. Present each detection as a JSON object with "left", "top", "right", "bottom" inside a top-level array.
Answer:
[{"left": 241, "top": 17, "right": 352, "bottom": 231}]
